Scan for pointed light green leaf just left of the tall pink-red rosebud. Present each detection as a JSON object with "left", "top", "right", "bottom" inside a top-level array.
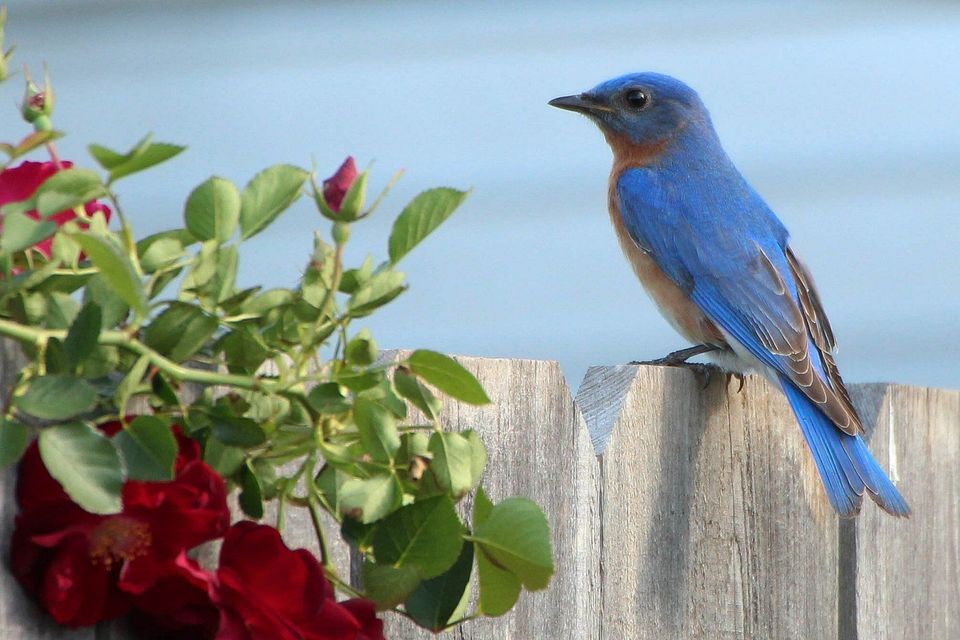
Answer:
[{"left": 240, "top": 164, "right": 309, "bottom": 240}]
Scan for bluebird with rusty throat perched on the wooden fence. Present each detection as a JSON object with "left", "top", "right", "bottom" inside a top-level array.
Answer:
[{"left": 549, "top": 72, "right": 910, "bottom": 517}]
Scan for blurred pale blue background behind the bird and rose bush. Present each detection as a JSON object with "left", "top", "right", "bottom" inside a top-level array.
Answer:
[{"left": 0, "top": 0, "right": 960, "bottom": 388}]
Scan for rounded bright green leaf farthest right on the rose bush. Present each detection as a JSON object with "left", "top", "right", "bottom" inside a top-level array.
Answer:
[{"left": 469, "top": 497, "right": 554, "bottom": 597}]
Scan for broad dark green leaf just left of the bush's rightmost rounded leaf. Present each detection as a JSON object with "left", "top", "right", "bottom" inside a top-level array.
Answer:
[{"left": 373, "top": 496, "right": 464, "bottom": 578}]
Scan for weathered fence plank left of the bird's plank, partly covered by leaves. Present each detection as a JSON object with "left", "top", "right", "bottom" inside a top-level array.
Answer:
[{"left": 376, "top": 358, "right": 600, "bottom": 640}]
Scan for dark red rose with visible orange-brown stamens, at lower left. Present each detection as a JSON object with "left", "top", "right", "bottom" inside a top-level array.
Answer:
[{"left": 11, "top": 425, "right": 230, "bottom": 626}]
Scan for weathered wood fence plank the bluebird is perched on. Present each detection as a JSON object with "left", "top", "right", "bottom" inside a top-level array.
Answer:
[{"left": 577, "top": 366, "right": 837, "bottom": 639}]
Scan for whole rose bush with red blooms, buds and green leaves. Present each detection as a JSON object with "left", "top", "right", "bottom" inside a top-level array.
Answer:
[{"left": 0, "top": 11, "right": 553, "bottom": 640}]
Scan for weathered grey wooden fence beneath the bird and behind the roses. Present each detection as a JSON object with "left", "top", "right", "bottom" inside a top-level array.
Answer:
[{"left": 0, "top": 354, "right": 960, "bottom": 640}]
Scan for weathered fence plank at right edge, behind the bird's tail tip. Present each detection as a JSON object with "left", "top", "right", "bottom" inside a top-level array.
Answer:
[{"left": 844, "top": 385, "right": 960, "bottom": 640}]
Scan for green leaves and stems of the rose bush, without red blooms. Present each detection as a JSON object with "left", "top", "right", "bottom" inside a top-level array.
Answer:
[{"left": 0, "top": 115, "right": 553, "bottom": 631}]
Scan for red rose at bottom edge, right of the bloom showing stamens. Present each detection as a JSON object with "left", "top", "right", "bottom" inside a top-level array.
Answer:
[{"left": 210, "top": 521, "right": 383, "bottom": 640}]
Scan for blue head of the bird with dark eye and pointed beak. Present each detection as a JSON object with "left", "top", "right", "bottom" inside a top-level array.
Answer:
[{"left": 550, "top": 73, "right": 709, "bottom": 146}]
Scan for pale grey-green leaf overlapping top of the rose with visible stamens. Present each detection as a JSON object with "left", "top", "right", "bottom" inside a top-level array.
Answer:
[{"left": 40, "top": 422, "right": 123, "bottom": 515}]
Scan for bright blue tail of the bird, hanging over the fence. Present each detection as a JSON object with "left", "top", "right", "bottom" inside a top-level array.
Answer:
[{"left": 780, "top": 376, "right": 910, "bottom": 517}]
